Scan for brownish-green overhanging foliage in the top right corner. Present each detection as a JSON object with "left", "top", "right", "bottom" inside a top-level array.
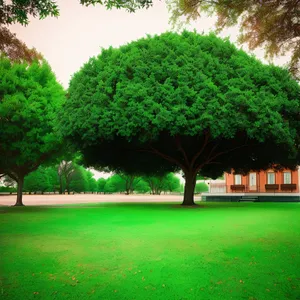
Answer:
[{"left": 167, "top": 0, "right": 300, "bottom": 78}]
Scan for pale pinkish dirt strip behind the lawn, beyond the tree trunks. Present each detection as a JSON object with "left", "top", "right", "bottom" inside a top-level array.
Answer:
[{"left": 0, "top": 194, "right": 200, "bottom": 206}]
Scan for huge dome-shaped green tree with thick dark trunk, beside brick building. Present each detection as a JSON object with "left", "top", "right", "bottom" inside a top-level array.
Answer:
[{"left": 61, "top": 32, "right": 300, "bottom": 205}]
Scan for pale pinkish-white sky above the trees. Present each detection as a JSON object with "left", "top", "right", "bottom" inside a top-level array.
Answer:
[{"left": 10, "top": 0, "right": 286, "bottom": 88}]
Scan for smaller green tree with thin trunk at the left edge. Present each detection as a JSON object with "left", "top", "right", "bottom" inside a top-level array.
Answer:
[{"left": 0, "top": 57, "right": 64, "bottom": 205}]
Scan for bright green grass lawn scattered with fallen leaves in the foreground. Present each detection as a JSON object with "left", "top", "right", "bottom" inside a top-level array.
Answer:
[{"left": 0, "top": 203, "right": 300, "bottom": 300}]
